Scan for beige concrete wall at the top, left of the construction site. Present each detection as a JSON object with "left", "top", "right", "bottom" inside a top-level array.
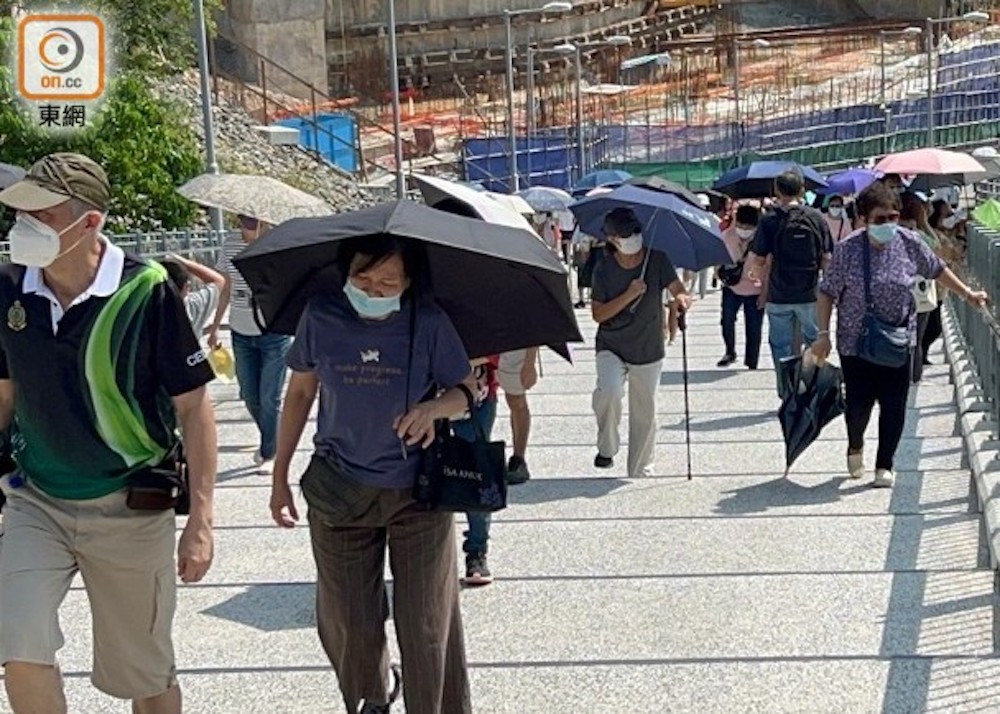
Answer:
[{"left": 226, "top": 0, "right": 328, "bottom": 99}]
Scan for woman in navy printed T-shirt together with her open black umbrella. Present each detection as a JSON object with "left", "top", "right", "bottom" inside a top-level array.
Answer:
[{"left": 234, "top": 196, "right": 581, "bottom": 714}]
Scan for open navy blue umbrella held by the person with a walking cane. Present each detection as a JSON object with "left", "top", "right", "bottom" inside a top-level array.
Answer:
[{"left": 570, "top": 186, "right": 732, "bottom": 270}]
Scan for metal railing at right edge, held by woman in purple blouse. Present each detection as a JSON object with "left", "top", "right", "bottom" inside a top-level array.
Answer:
[{"left": 949, "top": 222, "right": 1000, "bottom": 421}]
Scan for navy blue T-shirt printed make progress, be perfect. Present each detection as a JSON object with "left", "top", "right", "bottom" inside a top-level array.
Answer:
[{"left": 287, "top": 293, "right": 470, "bottom": 488}]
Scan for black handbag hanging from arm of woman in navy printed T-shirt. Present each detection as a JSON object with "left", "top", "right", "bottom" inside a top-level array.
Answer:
[{"left": 406, "top": 298, "right": 507, "bottom": 513}]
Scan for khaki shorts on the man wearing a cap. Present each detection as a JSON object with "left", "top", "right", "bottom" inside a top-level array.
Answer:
[{"left": 0, "top": 479, "right": 177, "bottom": 699}]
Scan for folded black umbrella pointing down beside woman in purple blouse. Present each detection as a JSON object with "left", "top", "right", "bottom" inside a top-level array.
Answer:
[{"left": 778, "top": 355, "right": 845, "bottom": 476}]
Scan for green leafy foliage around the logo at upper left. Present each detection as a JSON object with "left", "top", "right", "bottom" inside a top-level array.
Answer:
[{"left": 0, "top": 15, "right": 202, "bottom": 232}]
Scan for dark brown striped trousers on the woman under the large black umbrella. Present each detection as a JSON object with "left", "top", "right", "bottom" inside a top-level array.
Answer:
[{"left": 303, "top": 458, "right": 472, "bottom": 714}]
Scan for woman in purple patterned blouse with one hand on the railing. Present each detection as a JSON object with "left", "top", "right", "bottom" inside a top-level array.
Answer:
[{"left": 812, "top": 181, "right": 987, "bottom": 488}]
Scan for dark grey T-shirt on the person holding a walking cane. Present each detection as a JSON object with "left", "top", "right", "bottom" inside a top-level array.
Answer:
[{"left": 593, "top": 250, "right": 677, "bottom": 364}]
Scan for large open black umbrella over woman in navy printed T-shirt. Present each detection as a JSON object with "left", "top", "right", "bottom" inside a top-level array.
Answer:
[{"left": 233, "top": 201, "right": 583, "bottom": 359}]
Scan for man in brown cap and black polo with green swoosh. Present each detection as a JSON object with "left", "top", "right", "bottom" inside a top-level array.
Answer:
[{"left": 0, "top": 153, "right": 217, "bottom": 714}]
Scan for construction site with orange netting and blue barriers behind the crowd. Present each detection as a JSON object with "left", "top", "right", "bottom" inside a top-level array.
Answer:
[{"left": 213, "top": 0, "right": 1000, "bottom": 190}]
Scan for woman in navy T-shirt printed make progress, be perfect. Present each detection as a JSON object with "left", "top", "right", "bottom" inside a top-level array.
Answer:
[{"left": 271, "top": 236, "right": 476, "bottom": 714}]
